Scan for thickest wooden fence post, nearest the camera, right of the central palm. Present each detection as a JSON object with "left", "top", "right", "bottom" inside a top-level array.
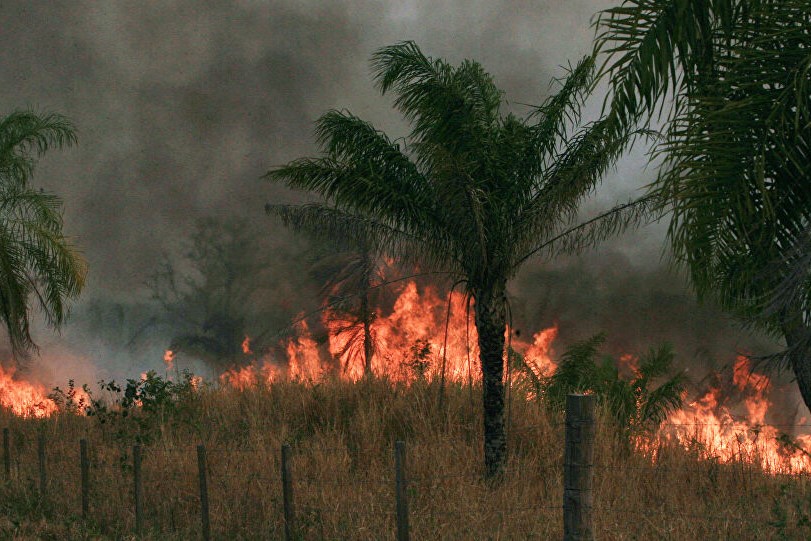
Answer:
[{"left": 563, "top": 394, "right": 596, "bottom": 541}]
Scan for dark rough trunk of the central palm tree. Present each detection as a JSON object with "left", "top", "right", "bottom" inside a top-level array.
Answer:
[{"left": 475, "top": 288, "right": 507, "bottom": 479}]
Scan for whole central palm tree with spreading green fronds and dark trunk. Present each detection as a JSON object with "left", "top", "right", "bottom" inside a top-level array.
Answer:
[{"left": 267, "top": 42, "right": 645, "bottom": 478}]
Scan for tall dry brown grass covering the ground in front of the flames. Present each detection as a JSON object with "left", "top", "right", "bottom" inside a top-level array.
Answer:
[{"left": 0, "top": 376, "right": 811, "bottom": 540}]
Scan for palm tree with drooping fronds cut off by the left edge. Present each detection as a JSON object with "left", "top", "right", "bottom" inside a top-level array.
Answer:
[{"left": 0, "top": 111, "right": 86, "bottom": 356}]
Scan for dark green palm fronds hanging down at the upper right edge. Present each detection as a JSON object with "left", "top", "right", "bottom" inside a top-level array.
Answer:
[{"left": 596, "top": 0, "right": 811, "bottom": 407}]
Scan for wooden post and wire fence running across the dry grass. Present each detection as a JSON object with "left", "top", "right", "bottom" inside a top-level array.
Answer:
[{"left": 2, "top": 395, "right": 811, "bottom": 541}]
